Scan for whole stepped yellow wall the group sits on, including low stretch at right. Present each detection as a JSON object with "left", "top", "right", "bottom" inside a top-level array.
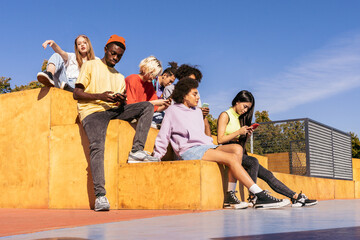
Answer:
[{"left": 0, "top": 88, "right": 360, "bottom": 209}]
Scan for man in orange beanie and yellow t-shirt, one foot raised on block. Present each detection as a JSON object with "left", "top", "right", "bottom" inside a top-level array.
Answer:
[{"left": 74, "top": 35, "right": 159, "bottom": 211}]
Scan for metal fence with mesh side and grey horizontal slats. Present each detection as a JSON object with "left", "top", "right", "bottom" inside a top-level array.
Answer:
[{"left": 246, "top": 118, "right": 353, "bottom": 180}]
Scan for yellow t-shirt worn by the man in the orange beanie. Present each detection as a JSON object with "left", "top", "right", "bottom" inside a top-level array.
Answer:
[{"left": 76, "top": 59, "right": 126, "bottom": 121}]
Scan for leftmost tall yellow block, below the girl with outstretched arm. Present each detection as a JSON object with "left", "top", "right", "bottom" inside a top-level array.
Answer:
[{"left": 0, "top": 90, "right": 50, "bottom": 208}]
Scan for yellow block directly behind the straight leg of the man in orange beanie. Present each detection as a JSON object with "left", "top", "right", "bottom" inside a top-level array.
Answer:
[{"left": 49, "top": 120, "right": 120, "bottom": 209}]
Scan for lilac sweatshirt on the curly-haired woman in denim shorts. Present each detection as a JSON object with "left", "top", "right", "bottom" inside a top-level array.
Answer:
[{"left": 154, "top": 103, "right": 213, "bottom": 159}]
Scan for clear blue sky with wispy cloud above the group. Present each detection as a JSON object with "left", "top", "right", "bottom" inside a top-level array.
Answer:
[{"left": 0, "top": 0, "right": 360, "bottom": 136}]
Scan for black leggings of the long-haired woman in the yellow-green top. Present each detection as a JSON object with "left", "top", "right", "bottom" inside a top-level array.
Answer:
[{"left": 242, "top": 154, "right": 295, "bottom": 198}]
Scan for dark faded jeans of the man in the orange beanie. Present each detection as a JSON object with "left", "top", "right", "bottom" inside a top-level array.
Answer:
[{"left": 82, "top": 102, "right": 154, "bottom": 196}]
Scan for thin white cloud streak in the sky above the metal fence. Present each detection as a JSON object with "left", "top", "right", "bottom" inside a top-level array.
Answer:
[{"left": 254, "top": 31, "right": 360, "bottom": 113}]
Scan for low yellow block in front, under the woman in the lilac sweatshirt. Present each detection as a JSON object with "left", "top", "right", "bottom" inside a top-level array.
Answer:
[{"left": 118, "top": 160, "right": 224, "bottom": 209}]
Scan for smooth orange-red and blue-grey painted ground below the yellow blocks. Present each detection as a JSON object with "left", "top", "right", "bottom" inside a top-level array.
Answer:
[{"left": 0, "top": 199, "right": 360, "bottom": 240}]
